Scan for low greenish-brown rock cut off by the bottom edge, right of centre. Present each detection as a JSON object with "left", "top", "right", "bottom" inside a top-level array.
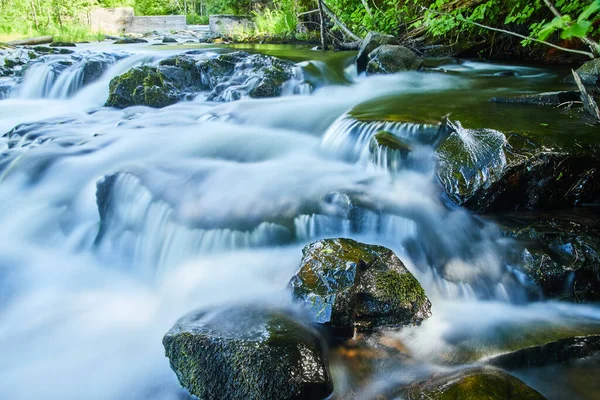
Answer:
[{"left": 394, "top": 367, "right": 545, "bottom": 400}]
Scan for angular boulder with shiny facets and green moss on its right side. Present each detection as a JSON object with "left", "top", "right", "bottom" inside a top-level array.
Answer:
[{"left": 290, "top": 239, "right": 431, "bottom": 336}]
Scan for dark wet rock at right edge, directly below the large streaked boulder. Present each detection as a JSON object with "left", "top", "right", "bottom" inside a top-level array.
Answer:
[{"left": 508, "top": 219, "right": 600, "bottom": 301}]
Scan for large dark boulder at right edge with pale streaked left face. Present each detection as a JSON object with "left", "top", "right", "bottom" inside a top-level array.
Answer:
[{"left": 437, "top": 124, "right": 600, "bottom": 213}]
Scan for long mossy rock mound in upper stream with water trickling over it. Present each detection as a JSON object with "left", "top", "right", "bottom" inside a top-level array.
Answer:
[{"left": 106, "top": 52, "right": 294, "bottom": 108}]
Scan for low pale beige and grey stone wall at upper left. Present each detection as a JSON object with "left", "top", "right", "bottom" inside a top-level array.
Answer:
[{"left": 89, "top": 7, "right": 187, "bottom": 33}]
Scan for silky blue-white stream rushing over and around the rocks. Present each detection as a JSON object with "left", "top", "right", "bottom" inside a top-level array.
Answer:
[{"left": 0, "top": 42, "right": 600, "bottom": 400}]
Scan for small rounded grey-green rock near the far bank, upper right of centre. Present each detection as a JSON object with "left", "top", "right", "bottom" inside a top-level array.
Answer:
[{"left": 367, "top": 44, "right": 423, "bottom": 74}]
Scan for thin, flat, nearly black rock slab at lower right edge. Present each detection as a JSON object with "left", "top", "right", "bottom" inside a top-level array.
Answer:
[{"left": 486, "top": 335, "right": 600, "bottom": 369}]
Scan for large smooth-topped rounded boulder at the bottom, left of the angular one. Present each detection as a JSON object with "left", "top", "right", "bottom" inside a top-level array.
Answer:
[{"left": 163, "top": 306, "right": 333, "bottom": 400}]
